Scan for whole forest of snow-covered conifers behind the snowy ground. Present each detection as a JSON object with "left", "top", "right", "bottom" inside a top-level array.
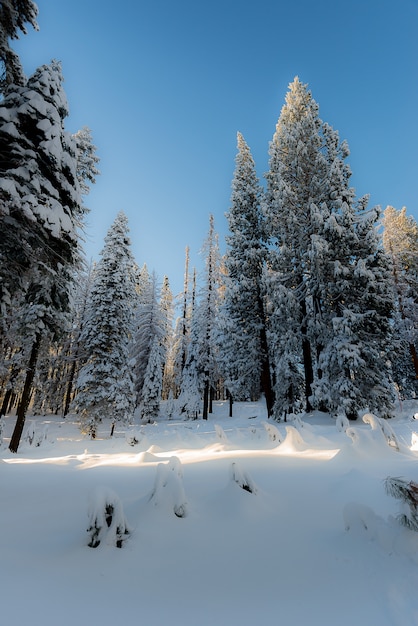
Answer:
[{"left": 0, "top": 0, "right": 418, "bottom": 452}]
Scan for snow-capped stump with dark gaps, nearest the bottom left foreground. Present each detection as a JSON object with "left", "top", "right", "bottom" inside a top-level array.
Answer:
[{"left": 87, "top": 487, "right": 130, "bottom": 548}]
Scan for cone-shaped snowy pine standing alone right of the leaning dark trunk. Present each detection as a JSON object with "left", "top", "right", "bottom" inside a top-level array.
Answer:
[{"left": 74, "top": 211, "right": 137, "bottom": 437}]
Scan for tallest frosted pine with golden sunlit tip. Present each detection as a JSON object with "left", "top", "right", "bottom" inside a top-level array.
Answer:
[{"left": 264, "top": 77, "right": 329, "bottom": 411}]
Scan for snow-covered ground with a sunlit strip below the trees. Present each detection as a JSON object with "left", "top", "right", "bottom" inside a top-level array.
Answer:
[{"left": 0, "top": 402, "right": 418, "bottom": 626}]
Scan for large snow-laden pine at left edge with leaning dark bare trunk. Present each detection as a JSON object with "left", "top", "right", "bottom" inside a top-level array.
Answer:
[{"left": 0, "top": 61, "right": 91, "bottom": 451}]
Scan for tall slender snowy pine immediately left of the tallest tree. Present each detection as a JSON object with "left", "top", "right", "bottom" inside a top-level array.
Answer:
[{"left": 219, "top": 133, "right": 273, "bottom": 414}]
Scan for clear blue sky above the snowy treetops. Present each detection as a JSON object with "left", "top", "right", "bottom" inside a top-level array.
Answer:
[{"left": 14, "top": 0, "right": 418, "bottom": 292}]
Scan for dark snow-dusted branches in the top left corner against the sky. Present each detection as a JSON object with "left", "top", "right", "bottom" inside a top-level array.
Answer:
[{"left": 0, "top": 0, "right": 38, "bottom": 92}]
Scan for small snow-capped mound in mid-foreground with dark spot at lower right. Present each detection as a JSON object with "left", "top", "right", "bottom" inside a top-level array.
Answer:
[{"left": 149, "top": 456, "right": 188, "bottom": 517}]
